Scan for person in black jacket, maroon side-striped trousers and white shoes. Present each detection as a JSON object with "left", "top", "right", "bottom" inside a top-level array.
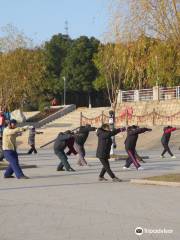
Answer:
[{"left": 123, "top": 125, "right": 152, "bottom": 170}]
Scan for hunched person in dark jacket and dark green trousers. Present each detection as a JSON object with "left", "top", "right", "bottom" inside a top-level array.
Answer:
[{"left": 54, "top": 131, "right": 75, "bottom": 172}]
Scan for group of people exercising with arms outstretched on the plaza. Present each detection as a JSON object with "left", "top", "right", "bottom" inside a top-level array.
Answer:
[{"left": 2, "top": 119, "right": 179, "bottom": 182}]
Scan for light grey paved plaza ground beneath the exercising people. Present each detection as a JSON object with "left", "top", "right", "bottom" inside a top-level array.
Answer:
[{"left": 0, "top": 150, "right": 180, "bottom": 240}]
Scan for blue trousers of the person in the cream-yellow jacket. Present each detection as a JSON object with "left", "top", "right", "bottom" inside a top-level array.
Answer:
[{"left": 4, "top": 150, "right": 24, "bottom": 178}]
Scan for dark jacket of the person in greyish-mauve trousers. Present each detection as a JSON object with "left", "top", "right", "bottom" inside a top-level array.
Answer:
[{"left": 75, "top": 126, "right": 96, "bottom": 146}]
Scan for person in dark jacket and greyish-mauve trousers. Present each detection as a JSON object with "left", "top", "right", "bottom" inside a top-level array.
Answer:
[{"left": 74, "top": 124, "right": 96, "bottom": 166}]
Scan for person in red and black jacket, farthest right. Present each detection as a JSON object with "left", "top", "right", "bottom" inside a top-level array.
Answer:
[{"left": 161, "top": 126, "right": 179, "bottom": 158}]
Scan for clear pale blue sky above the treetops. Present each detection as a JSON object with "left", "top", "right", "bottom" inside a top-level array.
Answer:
[{"left": 0, "top": 0, "right": 111, "bottom": 43}]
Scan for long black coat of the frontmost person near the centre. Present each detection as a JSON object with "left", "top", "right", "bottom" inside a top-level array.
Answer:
[{"left": 96, "top": 128, "right": 125, "bottom": 159}]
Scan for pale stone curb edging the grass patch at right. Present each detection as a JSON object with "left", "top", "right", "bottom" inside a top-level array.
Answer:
[{"left": 130, "top": 179, "right": 180, "bottom": 187}]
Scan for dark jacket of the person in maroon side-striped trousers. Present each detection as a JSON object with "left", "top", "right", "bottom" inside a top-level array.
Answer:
[{"left": 124, "top": 128, "right": 151, "bottom": 151}]
